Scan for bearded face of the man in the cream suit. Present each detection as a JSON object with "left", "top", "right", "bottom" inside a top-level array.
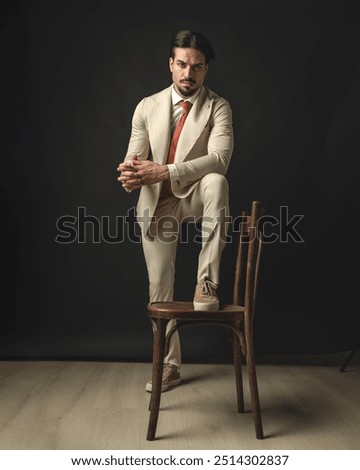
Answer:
[{"left": 169, "top": 47, "right": 208, "bottom": 98}]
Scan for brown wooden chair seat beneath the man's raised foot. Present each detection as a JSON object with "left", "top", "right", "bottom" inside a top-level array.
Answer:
[{"left": 147, "top": 301, "right": 244, "bottom": 321}]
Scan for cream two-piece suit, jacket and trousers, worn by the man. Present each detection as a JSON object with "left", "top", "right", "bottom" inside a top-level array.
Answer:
[{"left": 125, "top": 85, "right": 234, "bottom": 367}]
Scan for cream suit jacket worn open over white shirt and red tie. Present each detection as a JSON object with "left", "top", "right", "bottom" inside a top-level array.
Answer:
[{"left": 125, "top": 85, "right": 234, "bottom": 234}]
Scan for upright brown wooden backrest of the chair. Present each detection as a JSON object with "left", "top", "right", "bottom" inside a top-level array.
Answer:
[{"left": 233, "top": 201, "right": 264, "bottom": 323}]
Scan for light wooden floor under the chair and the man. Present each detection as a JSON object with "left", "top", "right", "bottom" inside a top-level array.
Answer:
[{"left": 0, "top": 361, "right": 360, "bottom": 450}]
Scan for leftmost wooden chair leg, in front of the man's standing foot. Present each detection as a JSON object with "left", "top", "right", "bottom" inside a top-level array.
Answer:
[{"left": 146, "top": 319, "right": 167, "bottom": 441}]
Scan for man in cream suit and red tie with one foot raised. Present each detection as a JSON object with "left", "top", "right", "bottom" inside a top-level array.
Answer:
[{"left": 117, "top": 30, "right": 234, "bottom": 391}]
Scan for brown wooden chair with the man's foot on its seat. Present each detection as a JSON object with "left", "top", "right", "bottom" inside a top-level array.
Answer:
[{"left": 147, "top": 201, "right": 264, "bottom": 441}]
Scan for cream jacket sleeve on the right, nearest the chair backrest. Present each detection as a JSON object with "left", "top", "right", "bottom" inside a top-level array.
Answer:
[{"left": 175, "top": 98, "right": 234, "bottom": 188}]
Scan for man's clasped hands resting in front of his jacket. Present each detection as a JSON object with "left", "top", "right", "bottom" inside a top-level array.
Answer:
[{"left": 117, "top": 154, "right": 169, "bottom": 192}]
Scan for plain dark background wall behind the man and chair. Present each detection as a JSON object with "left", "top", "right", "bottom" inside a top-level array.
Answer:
[{"left": 0, "top": 0, "right": 360, "bottom": 360}]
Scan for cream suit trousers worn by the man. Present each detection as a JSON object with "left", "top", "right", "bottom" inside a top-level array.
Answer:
[{"left": 142, "top": 173, "right": 230, "bottom": 368}]
